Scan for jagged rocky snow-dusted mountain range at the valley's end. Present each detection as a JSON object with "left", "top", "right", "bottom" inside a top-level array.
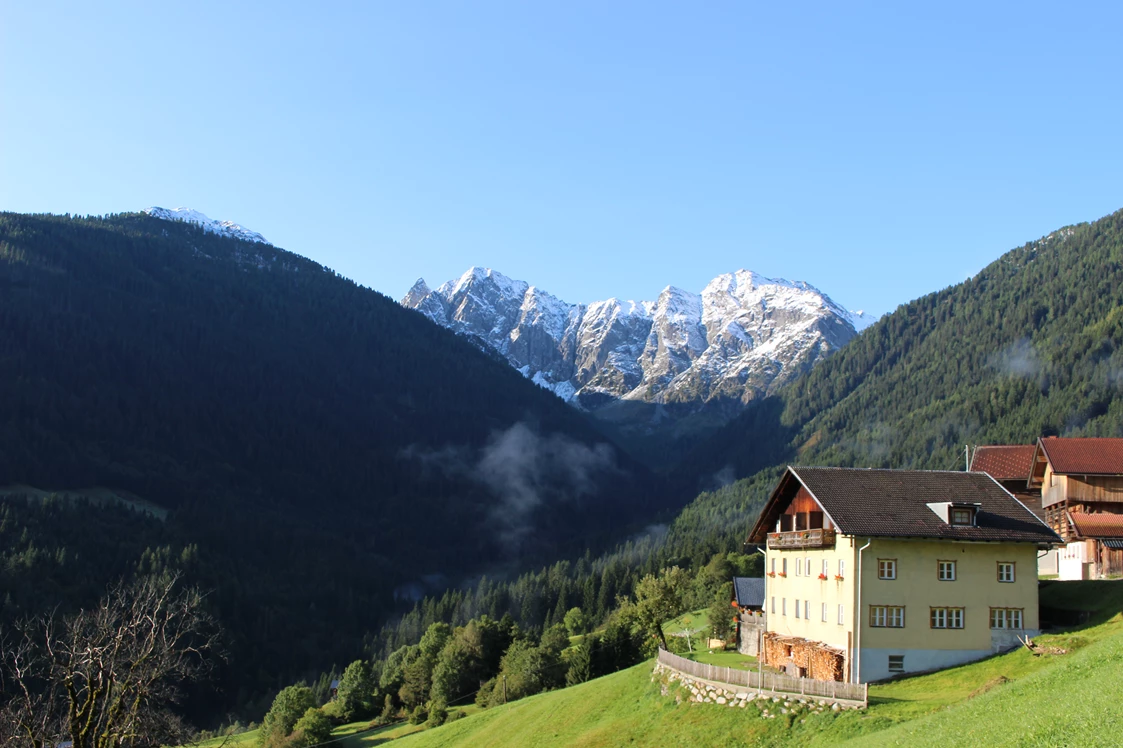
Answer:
[{"left": 401, "top": 267, "right": 876, "bottom": 408}]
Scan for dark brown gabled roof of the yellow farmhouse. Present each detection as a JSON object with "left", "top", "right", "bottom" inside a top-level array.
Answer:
[{"left": 749, "top": 467, "right": 1061, "bottom": 544}]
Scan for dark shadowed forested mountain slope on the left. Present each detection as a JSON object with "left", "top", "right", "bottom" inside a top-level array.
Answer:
[{"left": 0, "top": 213, "right": 666, "bottom": 714}]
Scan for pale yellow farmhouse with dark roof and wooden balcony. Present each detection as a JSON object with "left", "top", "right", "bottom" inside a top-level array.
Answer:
[{"left": 749, "top": 467, "right": 1060, "bottom": 683}]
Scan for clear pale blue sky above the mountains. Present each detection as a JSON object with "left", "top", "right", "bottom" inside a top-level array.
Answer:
[{"left": 0, "top": 0, "right": 1123, "bottom": 313}]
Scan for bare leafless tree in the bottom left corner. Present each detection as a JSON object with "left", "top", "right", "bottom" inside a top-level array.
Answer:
[{"left": 0, "top": 576, "right": 218, "bottom": 748}]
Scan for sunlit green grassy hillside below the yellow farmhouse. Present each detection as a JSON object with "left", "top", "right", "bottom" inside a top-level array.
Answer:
[{"left": 393, "top": 582, "right": 1123, "bottom": 748}]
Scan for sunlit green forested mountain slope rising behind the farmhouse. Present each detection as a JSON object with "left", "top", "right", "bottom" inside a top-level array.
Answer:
[{"left": 672, "top": 206, "right": 1123, "bottom": 557}]
